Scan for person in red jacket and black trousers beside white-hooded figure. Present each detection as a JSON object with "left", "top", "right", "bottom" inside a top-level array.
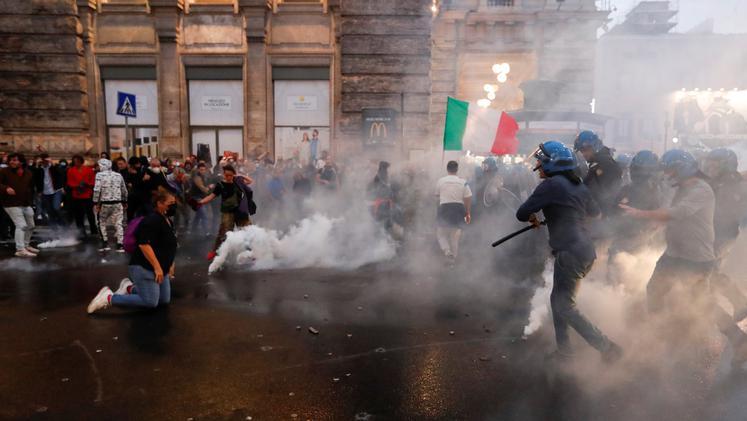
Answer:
[{"left": 67, "top": 155, "right": 98, "bottom": 239}]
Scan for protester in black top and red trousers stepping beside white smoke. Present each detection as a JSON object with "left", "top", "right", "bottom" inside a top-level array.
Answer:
[{"left": 198, "top": 165, "right": 253, "bottom": 260}]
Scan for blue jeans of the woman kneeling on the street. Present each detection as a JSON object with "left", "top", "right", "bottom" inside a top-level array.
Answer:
[{"left": 112, "top": 265, "right": 171, "bottom": 308}]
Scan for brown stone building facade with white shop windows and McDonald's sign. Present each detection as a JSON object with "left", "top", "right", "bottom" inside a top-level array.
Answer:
[{"left": 0, "top": 0, "right": 607, "bottom": 161}]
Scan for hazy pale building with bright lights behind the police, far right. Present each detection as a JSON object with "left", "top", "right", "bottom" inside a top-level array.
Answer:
[{"left": 595, "top": 1, "right": 747, "bottom": 152}]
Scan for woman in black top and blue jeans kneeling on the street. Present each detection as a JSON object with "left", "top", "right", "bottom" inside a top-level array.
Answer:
[{"left": 88, "top": 191, "right": 176, "bottom": 314}]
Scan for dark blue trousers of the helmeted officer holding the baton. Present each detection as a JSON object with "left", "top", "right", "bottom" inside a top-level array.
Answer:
[{"left": 550, "top": 251, "right": 610, "bottom": 354}]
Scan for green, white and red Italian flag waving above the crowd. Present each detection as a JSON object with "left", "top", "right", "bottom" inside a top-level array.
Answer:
[{"left": 444, "top": 98, "right": 519, "bottom": 155}]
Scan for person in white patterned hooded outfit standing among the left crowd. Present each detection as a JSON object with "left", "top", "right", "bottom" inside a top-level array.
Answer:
[{"left": 93, "top": 158, "right": 127, "bottom": 249}]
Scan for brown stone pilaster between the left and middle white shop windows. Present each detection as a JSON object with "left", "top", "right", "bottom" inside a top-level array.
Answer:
[{"left": 150, "top": 0, "right": 183, "bottom": 158}]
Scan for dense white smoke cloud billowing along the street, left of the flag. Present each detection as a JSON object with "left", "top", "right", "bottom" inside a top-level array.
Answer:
[{"left": 208, "top": 214, "right": 396, "bottom": 273}]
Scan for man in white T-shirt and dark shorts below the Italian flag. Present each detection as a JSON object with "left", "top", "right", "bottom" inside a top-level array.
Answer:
[{"left": 436, "top": 161, "right": 472, "bottom": 264}]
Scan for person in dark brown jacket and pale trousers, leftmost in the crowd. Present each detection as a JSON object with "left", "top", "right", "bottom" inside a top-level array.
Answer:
[{"left": 0, "top": 153, "right": 39, "bottom": 257}]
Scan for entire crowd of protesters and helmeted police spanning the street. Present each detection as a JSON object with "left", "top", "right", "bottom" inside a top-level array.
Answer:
[{"left": 0, "top": 131, "right": 747, "bottom": 368}]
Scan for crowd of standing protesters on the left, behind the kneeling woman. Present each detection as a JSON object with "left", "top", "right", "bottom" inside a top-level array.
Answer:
[{"left": 0, "top": 151, "right": 342, "bottom": 258}]
